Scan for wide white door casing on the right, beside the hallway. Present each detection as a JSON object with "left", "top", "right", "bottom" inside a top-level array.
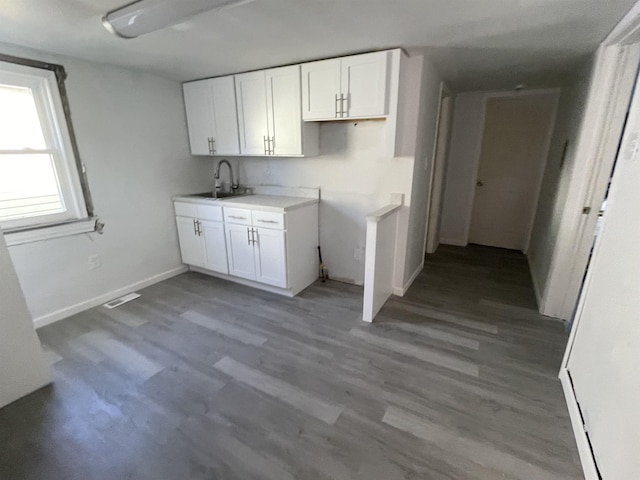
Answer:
[{"left": 539, "top": 11, "right": 640, "bottom": 320}]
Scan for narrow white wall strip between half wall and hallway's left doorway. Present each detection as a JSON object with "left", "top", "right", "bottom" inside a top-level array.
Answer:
[{"left": 403, "top": 58, "right": 443, "bottom": 288}]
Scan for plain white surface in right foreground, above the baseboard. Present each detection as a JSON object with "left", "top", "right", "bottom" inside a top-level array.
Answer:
[{"left": 568, "top": 78, "right": 640, "bottom": 480}]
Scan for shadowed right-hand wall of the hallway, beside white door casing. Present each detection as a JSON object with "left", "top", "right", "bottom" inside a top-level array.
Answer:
[{"left": 527, "top": 62, "right": 592, "bottom": 301}]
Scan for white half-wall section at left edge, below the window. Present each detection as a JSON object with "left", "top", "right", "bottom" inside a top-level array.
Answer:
[{"left": 0, "top": 230, "right": 51, "bottom": 407}]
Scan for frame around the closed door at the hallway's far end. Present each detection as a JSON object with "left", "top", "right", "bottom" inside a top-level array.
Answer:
[{"left": 464, "top": 88, "right": 560, "bottom": 249}]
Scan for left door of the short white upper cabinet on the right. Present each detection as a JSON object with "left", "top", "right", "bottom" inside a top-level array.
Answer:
[{"left": 302, "top": 58, "right": 341, "bottom": 120}]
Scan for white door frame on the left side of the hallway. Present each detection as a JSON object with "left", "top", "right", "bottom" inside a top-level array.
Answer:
[{"left": 422, "top": 82, "right": 454, "bottom": 259}]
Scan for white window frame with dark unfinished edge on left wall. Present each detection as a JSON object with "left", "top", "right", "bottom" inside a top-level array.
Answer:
[{"left": 0, "top": 54, "right": 95, "bottom": 245}]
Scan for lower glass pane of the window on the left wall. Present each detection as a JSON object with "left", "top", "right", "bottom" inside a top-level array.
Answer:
[{"left": 0, "top": 154, "right": 66, "bottom": 221}]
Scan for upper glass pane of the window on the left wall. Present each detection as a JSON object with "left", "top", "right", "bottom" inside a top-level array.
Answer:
[{"left": 0, "top": 85, "right": 47, "bottom": 150}]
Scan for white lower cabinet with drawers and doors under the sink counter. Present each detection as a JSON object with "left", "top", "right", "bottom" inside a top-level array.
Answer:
[{"left": 175, "top": 201, "right": 318, "bottom": 296}]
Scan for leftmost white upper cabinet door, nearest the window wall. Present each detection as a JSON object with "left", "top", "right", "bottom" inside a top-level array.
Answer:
[{"left": 182, "top": 80, "right": 215, "bottom": 155}]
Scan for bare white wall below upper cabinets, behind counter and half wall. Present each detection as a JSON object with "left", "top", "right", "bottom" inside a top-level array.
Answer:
[{"left": 236, "top": 121, "right": 413, "bottom": 285}]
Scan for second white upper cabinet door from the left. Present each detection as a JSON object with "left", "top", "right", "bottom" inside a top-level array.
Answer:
[{"left": 208, "top": 76, "right": 240, "bottom": 155}]
